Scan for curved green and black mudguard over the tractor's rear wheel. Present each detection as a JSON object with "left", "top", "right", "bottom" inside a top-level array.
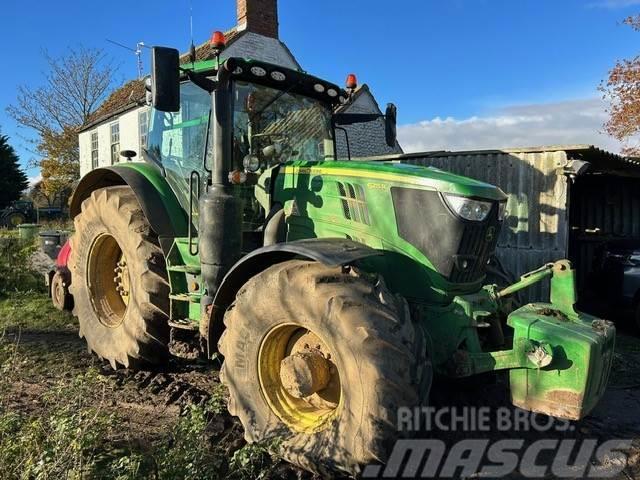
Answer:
[{"left": 69, "top": 163, "right": 188, "bottom": 238}]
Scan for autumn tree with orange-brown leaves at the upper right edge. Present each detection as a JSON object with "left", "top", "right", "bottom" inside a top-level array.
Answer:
[{"left": 600, "top": 15, "right": 640, "bottom": 156}]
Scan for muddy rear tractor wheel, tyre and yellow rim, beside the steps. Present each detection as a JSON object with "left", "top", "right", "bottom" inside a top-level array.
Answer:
[{"left": 69, "top": 186, "right": 169, "bottom": 369}]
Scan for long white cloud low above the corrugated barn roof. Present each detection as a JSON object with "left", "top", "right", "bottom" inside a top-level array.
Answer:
[{"left": 398, "top": 98, "right": 621, "bottom": 153}]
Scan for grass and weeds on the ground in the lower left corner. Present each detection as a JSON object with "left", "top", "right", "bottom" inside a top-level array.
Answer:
[{"left": 0, "top": 234, "right": 284, "bottom": 480}]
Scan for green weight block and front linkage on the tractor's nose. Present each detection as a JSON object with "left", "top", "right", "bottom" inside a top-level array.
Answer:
[{"left": 421, "top": 260, "right": 615, "bottom": 420}]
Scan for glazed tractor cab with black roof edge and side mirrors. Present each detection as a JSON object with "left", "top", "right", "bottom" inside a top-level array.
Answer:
[{"left": 145, "top": 47, "right": 396, "bottom": 253}]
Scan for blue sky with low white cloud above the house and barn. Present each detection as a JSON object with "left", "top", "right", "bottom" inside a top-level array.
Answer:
[{"left": 0, "top": 0, "right": 640, "bottom": 176}]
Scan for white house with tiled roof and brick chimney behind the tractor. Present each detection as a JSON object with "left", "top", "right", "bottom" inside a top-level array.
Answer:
[{"left": 79, "top": 0, "right": 402, "bottom": 176}]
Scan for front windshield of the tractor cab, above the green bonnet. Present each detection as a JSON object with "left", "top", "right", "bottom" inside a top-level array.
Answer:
[{"left": 233, "top": 81, "right": 334, "bottom": 169}]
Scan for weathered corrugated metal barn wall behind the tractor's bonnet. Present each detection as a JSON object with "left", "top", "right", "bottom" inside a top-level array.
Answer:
[{"left": 401, "top": 151, "right": 568, "bottom": 302}]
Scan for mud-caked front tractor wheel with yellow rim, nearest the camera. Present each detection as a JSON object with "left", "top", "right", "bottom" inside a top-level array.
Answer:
[{"left": 219, "top": 260, "right": 432, "bottom": 474}]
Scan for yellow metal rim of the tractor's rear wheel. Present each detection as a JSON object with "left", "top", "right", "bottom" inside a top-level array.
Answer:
[{"left": 87, "top": 233, "right": 130, "bottom": 328}]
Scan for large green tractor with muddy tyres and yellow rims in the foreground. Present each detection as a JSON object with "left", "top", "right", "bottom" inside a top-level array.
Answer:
[{"left": 69, "top": 41, "right": 615, "bottom": 474}]
